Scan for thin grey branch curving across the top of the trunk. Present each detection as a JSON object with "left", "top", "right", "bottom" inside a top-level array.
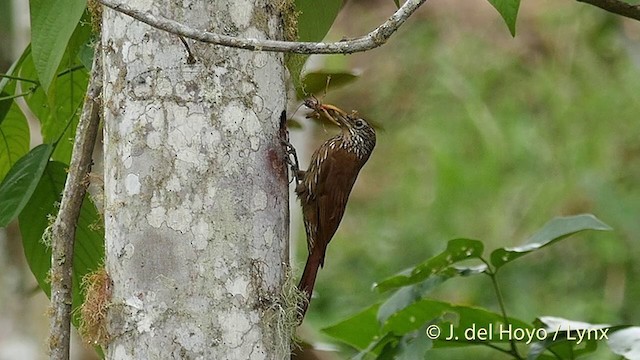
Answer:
[{"left": 99, "top": 0, "right": 426, "bottom": 54}]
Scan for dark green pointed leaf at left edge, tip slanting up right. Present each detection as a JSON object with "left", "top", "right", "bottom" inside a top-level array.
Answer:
[{"left": 0, "top": 144, "right": 53, "bottom": 227}]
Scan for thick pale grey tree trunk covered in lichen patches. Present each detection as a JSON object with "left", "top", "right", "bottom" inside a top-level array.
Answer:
[{"left": 102, "top": 0, "right": 289, "bottom": 360}]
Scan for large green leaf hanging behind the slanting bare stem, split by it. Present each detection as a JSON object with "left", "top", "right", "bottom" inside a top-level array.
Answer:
[{"left": 19, "top": 162, "right": 104, "bottom": 327}]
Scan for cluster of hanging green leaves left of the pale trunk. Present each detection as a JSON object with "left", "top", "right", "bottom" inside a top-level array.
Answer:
[{"left": 0, "top": 0, "right": 104, "bottom": 336}]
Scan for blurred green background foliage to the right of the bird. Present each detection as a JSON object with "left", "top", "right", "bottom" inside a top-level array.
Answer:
[{"left": 299, "top": 4, "right": 640, "bottom": 359}]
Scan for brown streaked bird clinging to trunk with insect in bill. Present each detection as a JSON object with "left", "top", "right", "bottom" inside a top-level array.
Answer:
[{"left": 295, "top": 99, "right": 376, "bottom": 318}]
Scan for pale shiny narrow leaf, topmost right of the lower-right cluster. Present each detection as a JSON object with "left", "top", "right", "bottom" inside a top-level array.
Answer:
[{"left": 491, "top": 214, "right": 611, "bottom": 270}]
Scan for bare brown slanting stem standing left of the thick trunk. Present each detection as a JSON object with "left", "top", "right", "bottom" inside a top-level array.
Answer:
[{"left": 49, "top": 47, "right": 102, "bottom": 360}]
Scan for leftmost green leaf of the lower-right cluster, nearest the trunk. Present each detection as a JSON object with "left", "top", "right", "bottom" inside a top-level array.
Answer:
[{"left": 322, "top": 304, "right": 380, "bottom": 350}]
